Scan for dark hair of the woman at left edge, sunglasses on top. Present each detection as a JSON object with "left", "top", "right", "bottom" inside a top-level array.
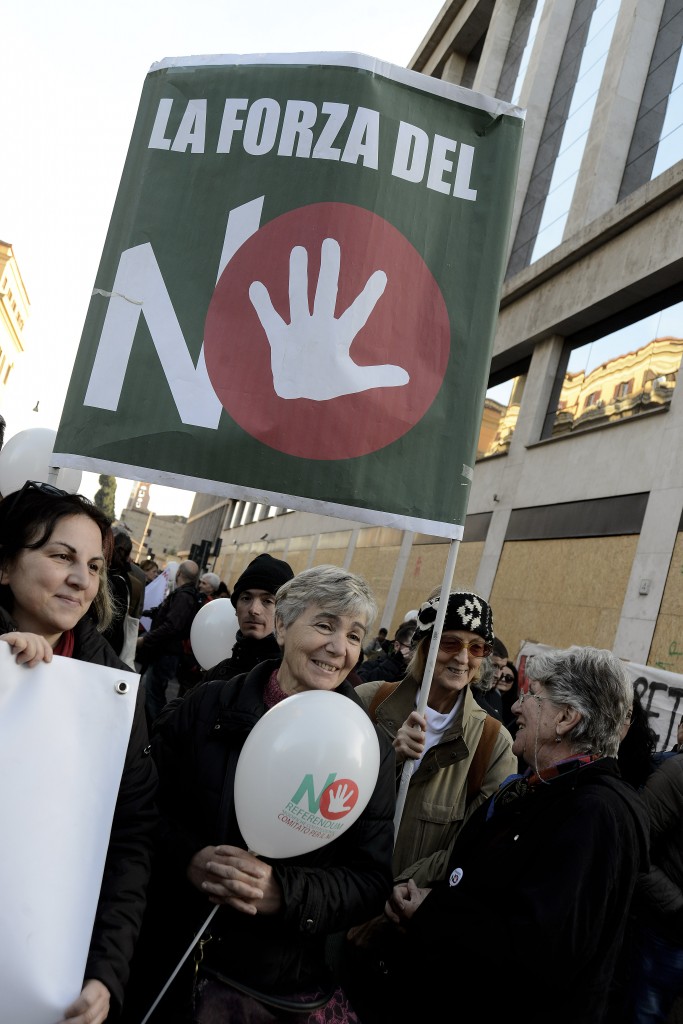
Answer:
[{"left": 0, "top": 481, "right": 114, "bottom": 632}]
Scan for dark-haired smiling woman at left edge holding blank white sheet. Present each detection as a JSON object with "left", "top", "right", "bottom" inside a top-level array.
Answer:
[{"left": 0, "top": 480, "right": 158, "bottom": 1024}]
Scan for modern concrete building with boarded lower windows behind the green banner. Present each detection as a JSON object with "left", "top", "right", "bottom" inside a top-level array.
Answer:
[{"left": 183, "top": 0, "right": 683, "bottom": 672}]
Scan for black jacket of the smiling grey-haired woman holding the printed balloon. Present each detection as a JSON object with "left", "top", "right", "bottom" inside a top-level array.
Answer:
[{"left": 141, "top": 662, "right": 395, "bottom": 992}]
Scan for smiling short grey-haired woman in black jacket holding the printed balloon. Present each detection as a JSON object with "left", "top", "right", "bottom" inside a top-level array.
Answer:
[{"left": 124, "top": 565, "right": 395, "bottom": 1024}]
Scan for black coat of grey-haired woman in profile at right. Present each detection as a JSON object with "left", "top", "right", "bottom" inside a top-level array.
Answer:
[{"left": 405, "top": 758, "right": 648, "bottom": 1024}]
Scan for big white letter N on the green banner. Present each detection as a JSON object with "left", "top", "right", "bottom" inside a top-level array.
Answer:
[{"left": 83, "top": 196, "right": 263, "bottom": 430}]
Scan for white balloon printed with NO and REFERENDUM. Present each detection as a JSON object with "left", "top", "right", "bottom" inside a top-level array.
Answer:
[{"left": 235, "top": 692, "right": 380, "bottom": 857}]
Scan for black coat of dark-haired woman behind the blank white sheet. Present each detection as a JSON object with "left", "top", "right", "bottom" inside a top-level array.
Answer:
[{"left": 0, "top": 608, "right": 158, "bottom": 1021}]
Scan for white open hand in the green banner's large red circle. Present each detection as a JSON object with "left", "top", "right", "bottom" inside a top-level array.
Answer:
[{"left": 249, "top": 239, "right": 411, "bottom": 401}]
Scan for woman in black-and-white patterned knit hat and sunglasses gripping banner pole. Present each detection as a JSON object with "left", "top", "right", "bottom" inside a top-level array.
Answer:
[{"left": 341, "top": 591, "right": 517, "bottom": 1007}]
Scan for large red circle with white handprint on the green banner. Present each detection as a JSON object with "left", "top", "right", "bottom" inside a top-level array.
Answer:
[{"left": 204, "top": 203, "right": 451, "bottom": 460}]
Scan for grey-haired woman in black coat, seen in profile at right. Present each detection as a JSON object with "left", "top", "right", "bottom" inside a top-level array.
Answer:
[{"left": 382, "top": 646, "right": 649, "bottom": 1024}]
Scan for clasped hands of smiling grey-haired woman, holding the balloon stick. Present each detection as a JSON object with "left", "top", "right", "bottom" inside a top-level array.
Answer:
[{"left": 187, "top": 846, "right": 282, "bottom": 914}]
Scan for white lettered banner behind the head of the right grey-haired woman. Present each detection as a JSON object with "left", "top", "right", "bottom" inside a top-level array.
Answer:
[{"left": 516, "top": 641, "right": 683, "bottom": 751}]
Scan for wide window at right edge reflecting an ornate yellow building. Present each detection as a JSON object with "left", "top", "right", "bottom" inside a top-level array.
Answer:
[{"left": 544, "top": 302, "right": 683, "bottom": 436}]
